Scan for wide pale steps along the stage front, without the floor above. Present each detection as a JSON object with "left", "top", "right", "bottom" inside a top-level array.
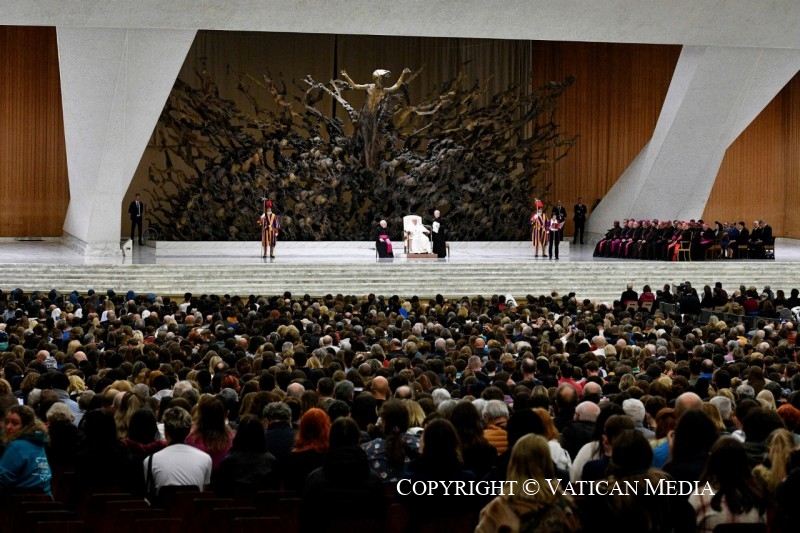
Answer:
[{"left": 0, "top": 258, "right": 800, "bottom": 302}]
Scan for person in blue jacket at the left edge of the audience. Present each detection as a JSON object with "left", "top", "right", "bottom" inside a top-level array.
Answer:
[{"left": 0, "top": 405, "right": 52, "bottom": 496}]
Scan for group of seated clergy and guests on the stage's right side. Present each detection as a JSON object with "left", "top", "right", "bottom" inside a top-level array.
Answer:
[{"left": 594, "top": 219, "right": 775, "bottom": 261}]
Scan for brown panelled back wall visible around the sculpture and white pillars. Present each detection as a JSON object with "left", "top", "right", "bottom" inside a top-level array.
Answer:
[{"left": 0, "top": 26, "right": 800, "bottom": 238}]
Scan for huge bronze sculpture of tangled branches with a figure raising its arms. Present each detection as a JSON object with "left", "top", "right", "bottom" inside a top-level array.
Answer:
[{"left": 139, "top": 37, "right": 574, "bottom": 241}]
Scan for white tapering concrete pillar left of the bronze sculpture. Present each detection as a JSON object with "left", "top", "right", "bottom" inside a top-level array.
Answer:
[{"left": 57, "top": 28, "right": 196, "bottom": 256}]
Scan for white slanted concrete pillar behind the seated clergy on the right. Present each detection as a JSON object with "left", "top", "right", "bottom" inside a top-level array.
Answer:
[{"left": 586, "top": 46, "right": 800, "bottom": 233}]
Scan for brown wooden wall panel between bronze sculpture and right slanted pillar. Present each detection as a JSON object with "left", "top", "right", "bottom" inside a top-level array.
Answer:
[{"left": 532, "top": 42, "right": 680, "bottom": 235}]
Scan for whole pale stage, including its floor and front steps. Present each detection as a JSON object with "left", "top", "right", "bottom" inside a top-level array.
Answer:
[{"left": 0, "top": 239, "right": 800, "bottom": 302}]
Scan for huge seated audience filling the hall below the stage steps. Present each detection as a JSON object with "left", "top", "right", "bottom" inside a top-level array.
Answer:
[{"left": 0, "top": 284, "right": 800, "bottom": 532}]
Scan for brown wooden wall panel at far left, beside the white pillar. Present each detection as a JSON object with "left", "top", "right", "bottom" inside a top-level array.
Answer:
[{"left": 0, "top": 26, "right": 69, "bottom": 237}]
